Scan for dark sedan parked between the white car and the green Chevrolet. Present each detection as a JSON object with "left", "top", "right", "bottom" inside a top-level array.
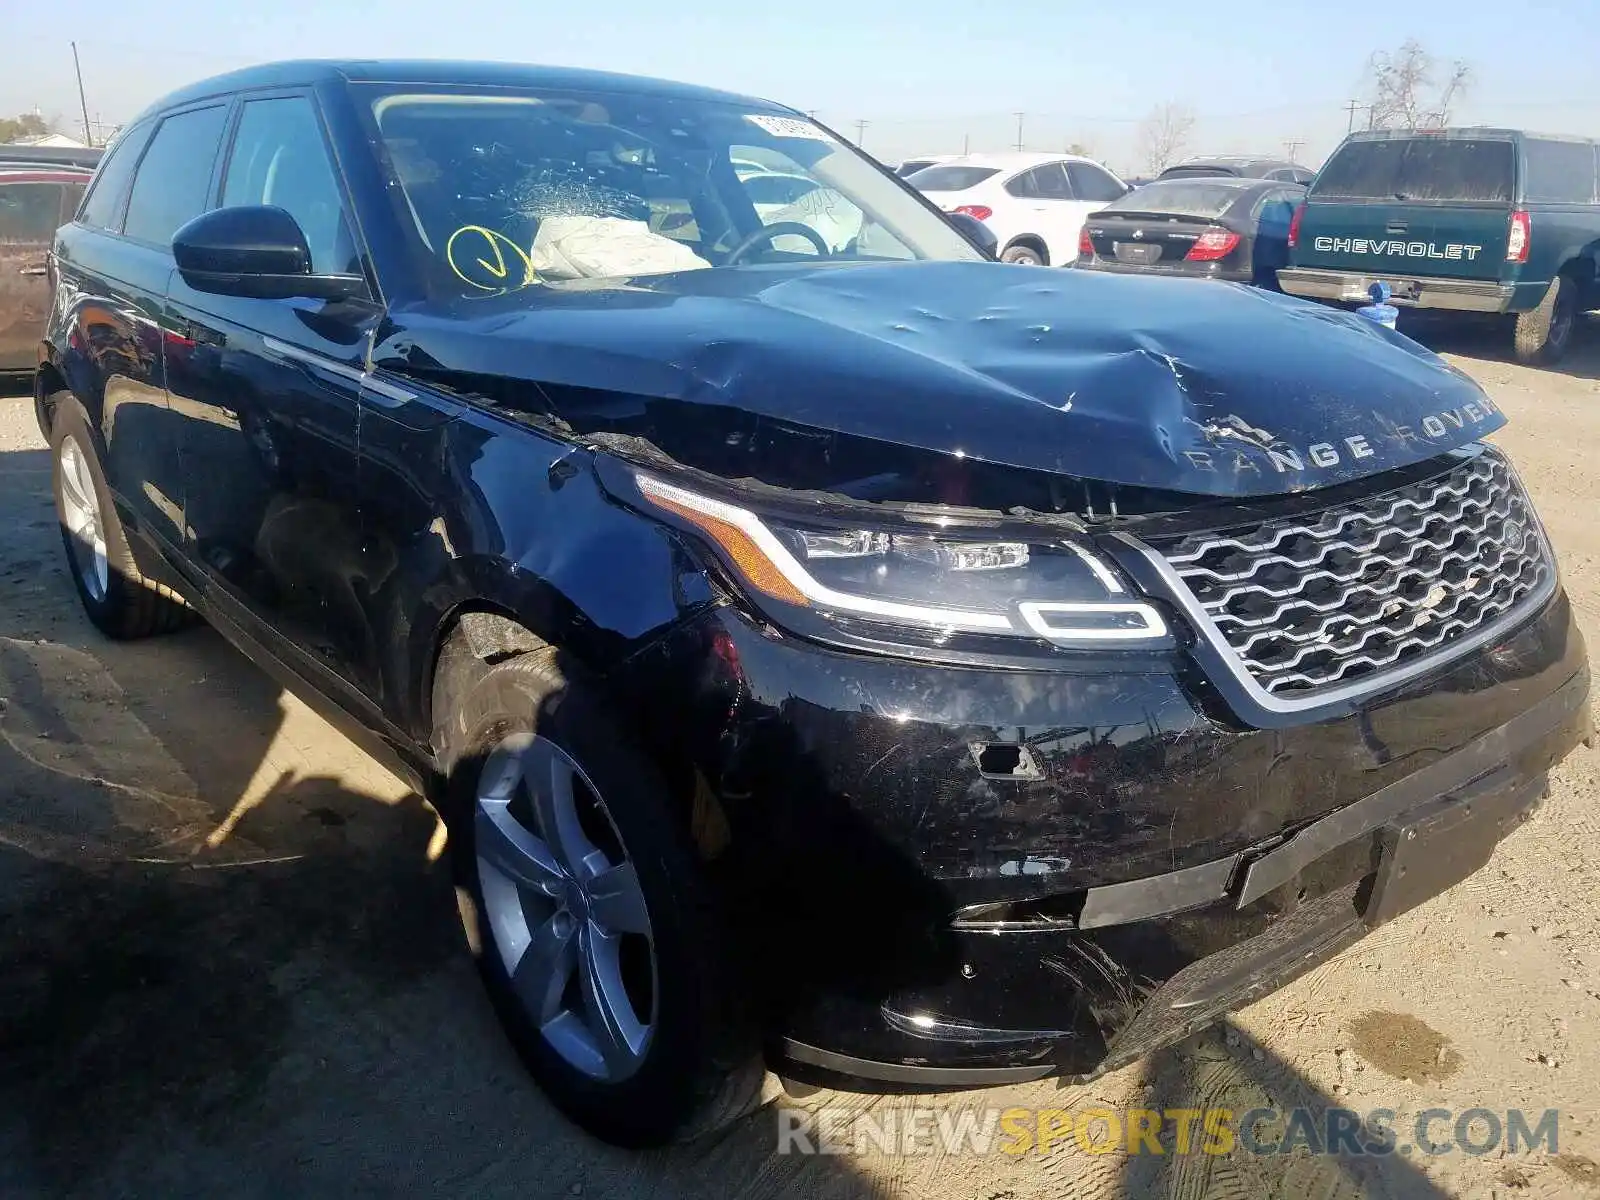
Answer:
[{"left": 1078, "top": 178, "right": 1306, "bottom": 288}]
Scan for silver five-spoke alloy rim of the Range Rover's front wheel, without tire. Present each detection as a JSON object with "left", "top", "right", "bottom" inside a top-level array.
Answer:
[{"left": 474, "top": 734, "right": 658, "bottom": 1083}]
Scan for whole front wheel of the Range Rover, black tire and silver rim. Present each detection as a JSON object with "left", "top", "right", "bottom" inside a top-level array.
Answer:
[{"left": 440, "top": 650, "right": 765, "bottom": 1147}]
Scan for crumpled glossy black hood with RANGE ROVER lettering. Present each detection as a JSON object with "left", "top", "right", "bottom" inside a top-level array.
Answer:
[{"left": 387, "top": 262, "right": 1504, "bottom": 496}]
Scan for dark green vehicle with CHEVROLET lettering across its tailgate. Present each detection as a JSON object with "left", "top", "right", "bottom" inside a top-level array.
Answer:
[{"left": 1278, "top": 128, "right": 1600, "bottom": 363}]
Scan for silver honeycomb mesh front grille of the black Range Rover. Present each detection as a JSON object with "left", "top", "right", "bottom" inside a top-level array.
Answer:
[{"left": 1160, "top": 450, "right": 1555, "bottom": 696}]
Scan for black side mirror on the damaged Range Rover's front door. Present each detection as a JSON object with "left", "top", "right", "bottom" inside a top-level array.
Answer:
[{"left": 173, "top": 205, "right": 366, "bottom": 299}]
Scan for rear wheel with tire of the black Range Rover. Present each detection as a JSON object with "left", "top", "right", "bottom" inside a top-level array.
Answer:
[{"left": 50, "top": 395, "right": 195, "bottom": 638}]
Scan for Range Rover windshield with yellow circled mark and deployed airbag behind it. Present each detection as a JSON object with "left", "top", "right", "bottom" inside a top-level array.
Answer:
[{"left": 370, "top": 86, "right": 979, "bottom": 294}]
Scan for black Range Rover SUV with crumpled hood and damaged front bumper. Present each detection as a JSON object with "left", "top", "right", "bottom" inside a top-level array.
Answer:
[{"left": 37, "top": 62, "right": 1589, "bottom": 1144}]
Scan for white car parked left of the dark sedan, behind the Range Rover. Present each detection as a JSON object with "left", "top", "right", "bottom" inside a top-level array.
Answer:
[{"left": 906, "top": 152, "right": 1128, "bottom": 266}]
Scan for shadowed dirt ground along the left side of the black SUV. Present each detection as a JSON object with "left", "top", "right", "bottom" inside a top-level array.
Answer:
[{"left": 0, "top": 450, "right": 889, "bottom": 1197}]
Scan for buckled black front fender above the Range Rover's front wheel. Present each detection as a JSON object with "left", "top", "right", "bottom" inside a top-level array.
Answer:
[{"left": 362, "top": 411, "right": 714, "bottom": 741}]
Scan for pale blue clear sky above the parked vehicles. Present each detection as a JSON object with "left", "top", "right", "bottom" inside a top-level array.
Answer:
[{"left": 0, "top": 0, "right": 1600, "bottom": 173}]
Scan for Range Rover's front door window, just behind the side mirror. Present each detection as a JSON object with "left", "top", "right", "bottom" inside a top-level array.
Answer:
[{"left": 222, "top": 96, "right": 362, "bottom": 275}]
